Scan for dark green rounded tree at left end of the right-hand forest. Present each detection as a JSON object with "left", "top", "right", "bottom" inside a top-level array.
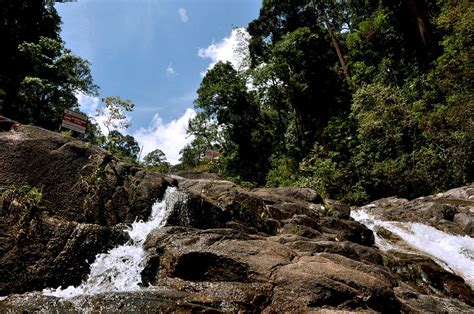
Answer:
[{"left": 195, "top": 62, "right": 268, "bottom": 182}]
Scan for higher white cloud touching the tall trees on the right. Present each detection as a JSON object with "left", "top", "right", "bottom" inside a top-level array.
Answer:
[{"left": 198, "top": 28, "right": 250, "bottom": 75}]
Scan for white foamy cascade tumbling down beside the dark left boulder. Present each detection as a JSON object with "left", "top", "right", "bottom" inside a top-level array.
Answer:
[{"left": 43, "top": 188, "right": 184, "bottom": 298}]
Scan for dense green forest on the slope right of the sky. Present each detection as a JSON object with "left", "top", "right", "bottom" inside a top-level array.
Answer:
[{"left": 182, "top": 0, "right": 474, "bottom": 203}]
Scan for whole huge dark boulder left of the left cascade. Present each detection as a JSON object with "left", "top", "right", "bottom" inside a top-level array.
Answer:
[{"left": 0, "top": 117, "right": 173, "bottom": 296}]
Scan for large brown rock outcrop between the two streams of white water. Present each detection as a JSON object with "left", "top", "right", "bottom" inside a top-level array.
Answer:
[{"left": 135, "top": 178, "right": 472, "bottom": 312}]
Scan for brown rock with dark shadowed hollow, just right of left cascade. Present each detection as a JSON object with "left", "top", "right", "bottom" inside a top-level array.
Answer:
[{"left": 141, "top": 227, "right": 294, "bottom": 283}]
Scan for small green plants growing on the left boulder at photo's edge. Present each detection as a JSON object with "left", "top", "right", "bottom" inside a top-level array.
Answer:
[{"left": 0, "top": 185, "right": 45, "bottom": 240}]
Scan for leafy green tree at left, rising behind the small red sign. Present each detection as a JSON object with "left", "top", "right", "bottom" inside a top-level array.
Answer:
[{"left": 3, "top": 37, "right": 97, "bottom": 129}]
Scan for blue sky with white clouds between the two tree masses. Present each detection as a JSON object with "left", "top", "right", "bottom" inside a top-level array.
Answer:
[{"left": 56, "top": 0, "right": 262, "bottom": 163}]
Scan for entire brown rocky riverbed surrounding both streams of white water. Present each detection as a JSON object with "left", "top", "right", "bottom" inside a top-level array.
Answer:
[{"left": 0, "top": 118, "right": 474, "bottom": 313}]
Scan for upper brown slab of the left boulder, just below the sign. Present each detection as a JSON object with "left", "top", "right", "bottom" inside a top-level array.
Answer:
[{"left": 0, "top": 118, "right": 173, "bottom": 226}]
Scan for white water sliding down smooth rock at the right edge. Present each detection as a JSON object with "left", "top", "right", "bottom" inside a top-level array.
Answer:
[{"left": 351, "top": 210, "right": 474, "bottom": 288}]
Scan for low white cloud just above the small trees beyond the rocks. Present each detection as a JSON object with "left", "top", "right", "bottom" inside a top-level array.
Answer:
[{"left": 133, "top": 108, "right": 196, "bottom": 164}]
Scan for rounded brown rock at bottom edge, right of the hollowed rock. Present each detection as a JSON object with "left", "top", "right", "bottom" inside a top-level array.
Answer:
[{"left": 266, "top": 254, "right": 400, "bottom": 312}]
